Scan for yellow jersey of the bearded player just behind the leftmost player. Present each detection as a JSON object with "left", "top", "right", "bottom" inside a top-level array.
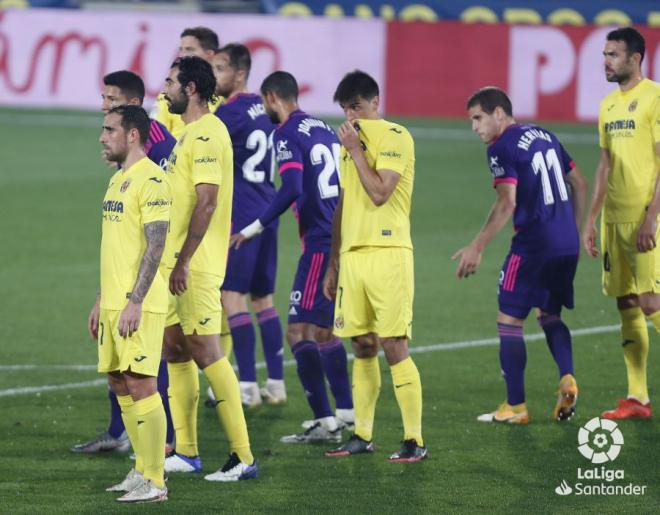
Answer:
[{"left": 163, "top": 113, "right": 234, "bottom": 277}]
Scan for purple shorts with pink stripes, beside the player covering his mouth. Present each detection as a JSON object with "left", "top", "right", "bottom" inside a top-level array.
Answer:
[{"left": 289, "top": 249, "right": 335, "bottom": 327}]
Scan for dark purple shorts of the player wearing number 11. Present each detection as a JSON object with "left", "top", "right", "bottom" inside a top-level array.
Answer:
[{"left": 497, "top": 252, "right": 578, "bottom": 319}]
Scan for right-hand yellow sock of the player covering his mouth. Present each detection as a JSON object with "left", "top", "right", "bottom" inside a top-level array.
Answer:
[{"left": 390, "top": 356, "right": 424, "bottom": 447}]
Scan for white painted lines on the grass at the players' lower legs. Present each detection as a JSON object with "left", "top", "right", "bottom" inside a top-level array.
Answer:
[{"left": 0, "top": 324, "right": 621, "bottom": 397}]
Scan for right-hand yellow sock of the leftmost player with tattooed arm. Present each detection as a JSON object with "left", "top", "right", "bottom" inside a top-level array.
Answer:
[{"left": 133, "top": 392, "right": 167, "bottom": 488}]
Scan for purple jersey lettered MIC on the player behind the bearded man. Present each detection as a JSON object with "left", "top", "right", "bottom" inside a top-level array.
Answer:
[{"left": 215, "top": 93, "right": 275, "bottom": 228}]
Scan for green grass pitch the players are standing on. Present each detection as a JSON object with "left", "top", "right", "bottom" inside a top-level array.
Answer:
[{"left": 0, "top": 109, "right": 660, "bottom": 514}]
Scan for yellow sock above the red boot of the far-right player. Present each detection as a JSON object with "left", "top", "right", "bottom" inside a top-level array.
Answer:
[{"left": 619, "top": 307, "right": 648, "bottom": 404}]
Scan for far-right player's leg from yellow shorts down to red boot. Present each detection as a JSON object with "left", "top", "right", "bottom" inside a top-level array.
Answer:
[{"left": 602, "top": 224, "right": 656, "bottom": 419}]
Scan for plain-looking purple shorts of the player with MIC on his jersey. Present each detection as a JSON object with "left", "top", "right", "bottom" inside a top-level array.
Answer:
[{"left": 222, "top": 225, "right": 277, "bottom": 297}]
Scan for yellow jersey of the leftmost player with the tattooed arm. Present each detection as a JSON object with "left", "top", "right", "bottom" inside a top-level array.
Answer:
[{"left": 101, "top": 157, "right": 171, "bottom": 313}]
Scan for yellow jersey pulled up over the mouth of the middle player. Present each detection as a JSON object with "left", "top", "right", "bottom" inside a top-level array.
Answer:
[{"left": 340, "top": 120, "right": 415, "bottom": 252}]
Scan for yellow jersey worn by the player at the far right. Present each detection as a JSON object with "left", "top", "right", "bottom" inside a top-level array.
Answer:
[{"left": 598, "top": 79, "right": 660, "bottom": 223}]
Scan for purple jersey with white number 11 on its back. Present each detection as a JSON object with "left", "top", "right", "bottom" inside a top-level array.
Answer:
[{"left": 488, "top": 125, "right": 579, "bottom": 256}]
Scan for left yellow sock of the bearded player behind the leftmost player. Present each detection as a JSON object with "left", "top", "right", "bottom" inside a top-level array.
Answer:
[{"left": 167, "top": 360, "right": 199, "bottom": 456}]
